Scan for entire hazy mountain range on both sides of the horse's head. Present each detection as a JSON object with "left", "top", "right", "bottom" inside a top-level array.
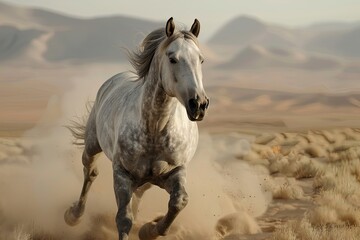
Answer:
[{"left": 0, "top": 2, "right": 360, "bottom": 62}]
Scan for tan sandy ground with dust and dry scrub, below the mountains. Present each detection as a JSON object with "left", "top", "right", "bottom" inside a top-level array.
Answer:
[{"left": 0, "top": 58, "right": 360, "bottom": 240}]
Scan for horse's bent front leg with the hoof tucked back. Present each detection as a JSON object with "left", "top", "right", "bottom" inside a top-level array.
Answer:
[{"left": 139, "top": 167, "right": 188, "bottom": 240}]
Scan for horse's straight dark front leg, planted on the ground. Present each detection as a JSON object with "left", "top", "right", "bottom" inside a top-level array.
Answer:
[{"left": 114, "top": 167, "right": 134, "bottom": 240}]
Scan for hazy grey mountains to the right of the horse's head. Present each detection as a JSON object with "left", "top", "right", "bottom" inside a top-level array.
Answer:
[{"left": 208, "top": 16, "right": 360, "bottom": 58}]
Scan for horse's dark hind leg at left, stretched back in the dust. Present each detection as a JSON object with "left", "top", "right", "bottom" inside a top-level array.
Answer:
[{"left": 64, "top": 140, "right": 101, "bottom": 226}]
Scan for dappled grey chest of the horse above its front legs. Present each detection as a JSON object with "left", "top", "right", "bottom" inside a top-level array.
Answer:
[{"left": 116, "top": 127, "right": 197, "bottom": 179}]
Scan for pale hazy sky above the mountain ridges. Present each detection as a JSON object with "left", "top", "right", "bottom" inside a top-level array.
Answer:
[{"left": 0, "top": 0, "right": 360, "bottom": 36}]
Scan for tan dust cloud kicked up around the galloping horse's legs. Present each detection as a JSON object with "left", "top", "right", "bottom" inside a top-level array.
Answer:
[{"left": 0, "top": 71, "right": 271, "bottom": 240}]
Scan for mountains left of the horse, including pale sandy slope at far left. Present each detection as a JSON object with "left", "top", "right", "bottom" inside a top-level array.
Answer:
[{"left": 0, "top": 2, "right": 163, "bottom": 61}]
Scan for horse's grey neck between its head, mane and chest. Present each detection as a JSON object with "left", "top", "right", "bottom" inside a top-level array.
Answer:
[{"left": 141, "top": 59, "right": 178, "bottom": 132}]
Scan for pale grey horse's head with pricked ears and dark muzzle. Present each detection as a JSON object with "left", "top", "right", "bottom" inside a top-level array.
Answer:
[{"left": 160, "top": 18, "right": 209, "bottom": 121}]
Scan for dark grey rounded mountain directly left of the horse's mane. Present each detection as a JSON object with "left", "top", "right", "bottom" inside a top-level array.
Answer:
[{"left": 44, "top": 17, "right": 161, "bottom": 61}]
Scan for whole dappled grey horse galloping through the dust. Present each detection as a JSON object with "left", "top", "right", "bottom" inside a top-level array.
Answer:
[{"left": 64, "top": 17, "right": 209, "bottom": 240}]
